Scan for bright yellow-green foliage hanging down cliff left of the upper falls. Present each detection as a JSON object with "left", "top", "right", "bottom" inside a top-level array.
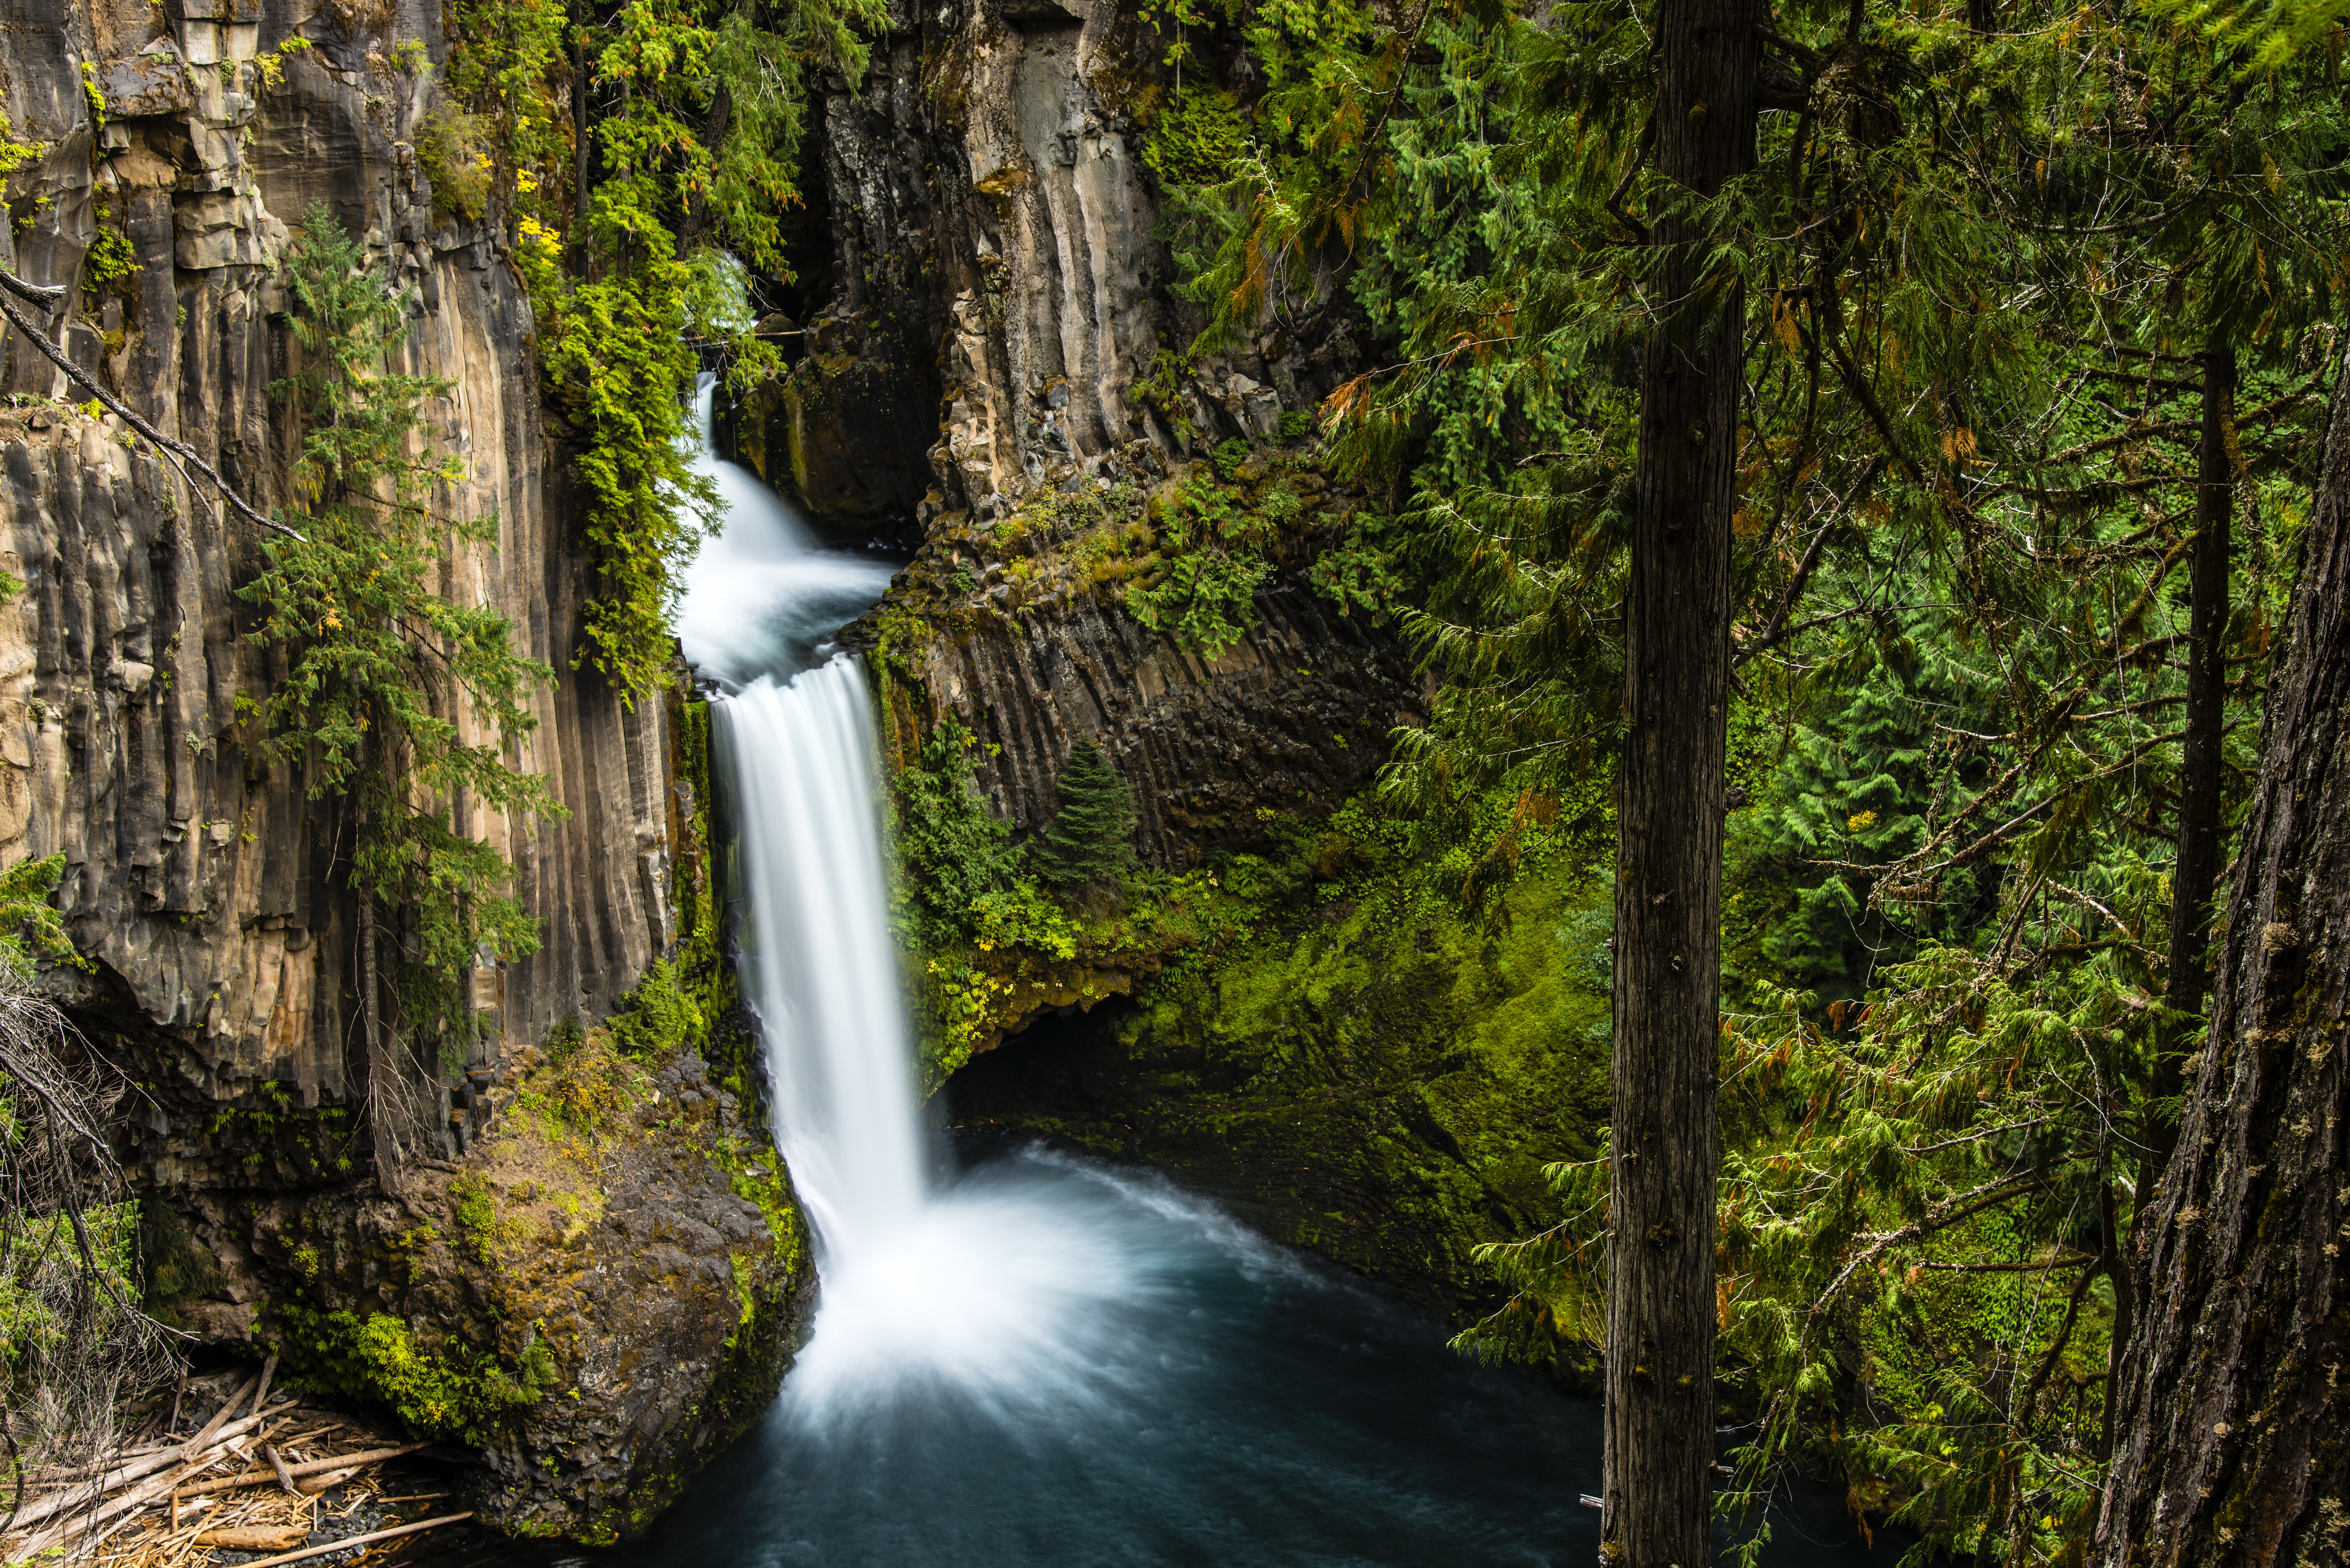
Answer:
[{"left": 449, "top": 0, "right": 884, "bottom": 701}]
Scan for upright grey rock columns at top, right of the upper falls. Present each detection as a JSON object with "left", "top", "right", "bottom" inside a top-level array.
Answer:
[{"left": 768, "top": 0, "right": 1356, "bottom": 522}]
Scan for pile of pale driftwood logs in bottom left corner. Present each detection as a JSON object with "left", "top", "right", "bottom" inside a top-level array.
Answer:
[{"left": 0, "top": 1356, "right": 470, "bottom": 1568}]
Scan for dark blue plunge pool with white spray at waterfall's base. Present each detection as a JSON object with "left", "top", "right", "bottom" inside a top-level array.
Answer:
[{"left": 533, "top": 1145, "right": 1899, "bottom": 1568}]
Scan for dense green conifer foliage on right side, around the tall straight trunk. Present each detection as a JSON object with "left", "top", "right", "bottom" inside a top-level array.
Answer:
[{"left": 1168, "top": 0, "right": 2350, "bottom": 1565}]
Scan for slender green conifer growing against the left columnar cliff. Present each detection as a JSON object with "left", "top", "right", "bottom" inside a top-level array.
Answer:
[{"left": 240, "top": 205, "right": 564, "bottom": 1043}]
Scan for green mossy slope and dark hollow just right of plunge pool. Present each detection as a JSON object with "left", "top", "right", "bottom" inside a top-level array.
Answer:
[{"left": 949, "top": 804, "right": 1612, "bottom": 1317}]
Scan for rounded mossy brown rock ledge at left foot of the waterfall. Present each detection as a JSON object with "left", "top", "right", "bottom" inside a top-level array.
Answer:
[{"left": 161, "top": 1032, "right": 816, "bottom": 1542}]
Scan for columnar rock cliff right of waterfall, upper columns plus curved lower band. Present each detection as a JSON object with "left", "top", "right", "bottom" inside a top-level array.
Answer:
[{"left": 743, "top": 0, "right": 1419, "bottom": 867}]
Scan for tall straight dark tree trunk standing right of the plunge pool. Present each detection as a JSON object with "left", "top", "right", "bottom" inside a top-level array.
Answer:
[{"left": 1600, "top": 0, "right": 1760, "bottom": 1568}]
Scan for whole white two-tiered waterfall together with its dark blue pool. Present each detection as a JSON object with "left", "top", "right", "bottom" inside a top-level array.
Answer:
[{"left": 611, "top": 386, "right": 1861, "bottom": 1568}]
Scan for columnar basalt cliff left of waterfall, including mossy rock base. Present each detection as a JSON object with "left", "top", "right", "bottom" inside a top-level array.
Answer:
[{"left": 0, "top": 0, "right": 811, "bottom": 1537}]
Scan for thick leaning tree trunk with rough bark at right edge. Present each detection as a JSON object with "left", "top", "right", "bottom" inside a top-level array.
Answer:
[{"left": 2099, "top": 350, "right": 2350, "bottom": 1568}]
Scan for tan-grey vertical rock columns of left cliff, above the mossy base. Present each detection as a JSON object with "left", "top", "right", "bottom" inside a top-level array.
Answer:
[{"left": 0, "top": 0, "right": 675, "bottom": 1171}]
